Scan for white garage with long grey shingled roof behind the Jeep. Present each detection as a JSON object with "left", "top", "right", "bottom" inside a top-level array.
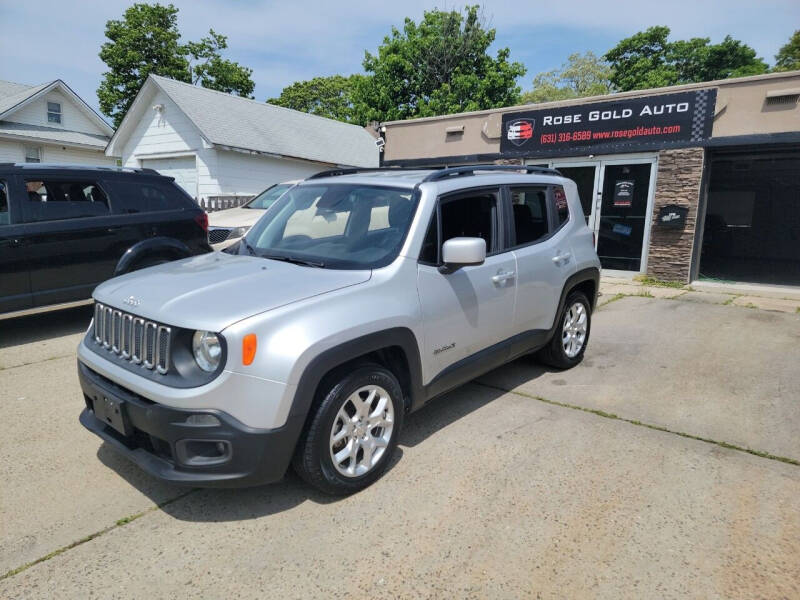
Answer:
[{"left": 106, "top": 75, "right": 378, "bottom": 207}]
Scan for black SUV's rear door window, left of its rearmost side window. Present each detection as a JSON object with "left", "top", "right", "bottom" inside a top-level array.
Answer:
[{"left": 25, "top": 179, "right": 109, "bottom": 222}]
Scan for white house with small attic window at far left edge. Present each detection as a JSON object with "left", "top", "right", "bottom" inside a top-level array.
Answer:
[{"left": 0, "top": 79, "right": 116, "bottom": 165}]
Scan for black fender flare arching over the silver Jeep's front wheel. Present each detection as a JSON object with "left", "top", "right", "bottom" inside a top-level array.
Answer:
[{"left": 289, "top": 327, "right": 424, "bottom": 421}]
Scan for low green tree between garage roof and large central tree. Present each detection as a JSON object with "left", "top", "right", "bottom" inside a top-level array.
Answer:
[{"left": 267, "top": 74, "right": 366, "bottom": 125}]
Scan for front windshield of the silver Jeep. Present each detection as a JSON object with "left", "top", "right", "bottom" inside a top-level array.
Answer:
[{"left": 238, "top": 184, "right": 416, "bottom": 269}]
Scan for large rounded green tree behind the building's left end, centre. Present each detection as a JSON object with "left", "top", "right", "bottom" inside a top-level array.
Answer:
[{"left": 353, "top": 6, "right": 525, "bottom": 121}]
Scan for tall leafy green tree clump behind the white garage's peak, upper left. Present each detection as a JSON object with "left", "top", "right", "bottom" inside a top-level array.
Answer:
[{"left": 97, "top": 3, "right": 254, "bottom": 127}]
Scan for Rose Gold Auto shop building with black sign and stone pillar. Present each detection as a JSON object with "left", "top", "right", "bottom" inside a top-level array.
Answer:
[{"left": 381, "top": 71, "right": 800, "bottom": 285}]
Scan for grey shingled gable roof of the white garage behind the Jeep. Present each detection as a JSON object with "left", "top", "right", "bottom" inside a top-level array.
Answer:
[{"left": 106, "top": 75, "right": 378, "bottom": 167}]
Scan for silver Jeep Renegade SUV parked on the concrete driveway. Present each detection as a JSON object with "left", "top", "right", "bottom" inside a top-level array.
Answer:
[{"left": 78, "top": 165, "right": 600, "bottom": 494}]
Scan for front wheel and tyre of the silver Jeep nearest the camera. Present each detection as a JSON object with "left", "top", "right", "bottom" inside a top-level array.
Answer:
[{"left": 292, "top": 364, "right": 403, "bottom": 494}]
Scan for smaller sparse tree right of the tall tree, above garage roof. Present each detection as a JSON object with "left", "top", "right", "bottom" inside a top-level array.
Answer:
[{"left": 186, "top": 29, "right": 255, "bottom": 98}]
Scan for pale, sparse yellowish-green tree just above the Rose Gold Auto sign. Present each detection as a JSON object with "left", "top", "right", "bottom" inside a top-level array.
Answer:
[{"left": 522, "top": 52, "right": 613, "bottom": 104}]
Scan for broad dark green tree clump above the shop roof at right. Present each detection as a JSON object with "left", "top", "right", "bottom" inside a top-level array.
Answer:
[{"left": 604, "top": 26, "right": 767, "bottom": 91}]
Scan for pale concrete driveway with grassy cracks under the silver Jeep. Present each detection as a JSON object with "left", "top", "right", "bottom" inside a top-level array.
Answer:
[{"left": 0, "top": 294, "right": 800, "bottom": 598}]
